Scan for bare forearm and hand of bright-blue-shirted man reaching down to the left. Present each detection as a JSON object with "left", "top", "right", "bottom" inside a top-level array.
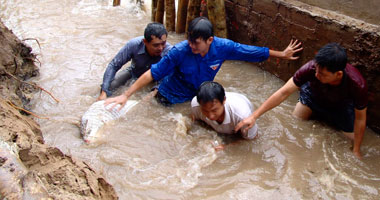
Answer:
[{"left": 105, "top": 70, "right": 153, "bottom": 110}]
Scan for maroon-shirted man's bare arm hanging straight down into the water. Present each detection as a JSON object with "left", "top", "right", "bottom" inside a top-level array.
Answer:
[{"left": 353, "top": 108, "right": 367, "bottom": 158}]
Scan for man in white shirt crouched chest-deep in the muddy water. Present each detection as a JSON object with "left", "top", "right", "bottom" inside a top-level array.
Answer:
[{"left": 191, "top": 81, "right": 257, "bottom": 139}]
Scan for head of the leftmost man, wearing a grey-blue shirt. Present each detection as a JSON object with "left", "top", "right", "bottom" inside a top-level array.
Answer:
[{"left": 144, "top": 22, "right": 168, "bottom": 56}]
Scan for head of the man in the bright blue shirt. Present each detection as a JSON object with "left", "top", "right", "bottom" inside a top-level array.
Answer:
[{"left": 187, "top": 17, "right": 214, "bottom": 56}]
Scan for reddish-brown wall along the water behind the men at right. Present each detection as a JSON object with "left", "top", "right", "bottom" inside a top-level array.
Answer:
[{"left": 225, "top": 0, "right": 380, "bottom": 133}]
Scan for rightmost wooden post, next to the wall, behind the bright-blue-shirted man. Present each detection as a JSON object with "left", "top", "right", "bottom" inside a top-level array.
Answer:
[{"left": 207, "top": 0, "right": 227, "bottom": 38}]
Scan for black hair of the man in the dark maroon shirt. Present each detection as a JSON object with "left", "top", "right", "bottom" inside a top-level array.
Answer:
[{"left": 314, "top": 43, "right": 347, "bottom": 73}]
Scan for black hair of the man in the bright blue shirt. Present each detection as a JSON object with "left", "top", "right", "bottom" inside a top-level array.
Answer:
[{"left": 187, "top": 17, "right": 214, "bottom": 43}]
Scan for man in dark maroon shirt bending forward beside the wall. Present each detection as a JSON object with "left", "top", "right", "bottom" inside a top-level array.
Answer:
[{"left": 235, "top": 43, "right": 368, "bottom": 158}]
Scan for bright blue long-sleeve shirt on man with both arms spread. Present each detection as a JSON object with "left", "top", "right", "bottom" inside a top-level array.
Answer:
[{"left": 151, "top": 37, "right": 269, "bottom": 104}]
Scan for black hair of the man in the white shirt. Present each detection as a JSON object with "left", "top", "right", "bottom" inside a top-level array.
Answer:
[{"left": 197, "top": 81, "right": 226, "bottom": 104}]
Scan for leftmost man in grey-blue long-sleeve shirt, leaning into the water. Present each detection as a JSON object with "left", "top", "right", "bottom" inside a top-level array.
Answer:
[{"left": 98, "top": 23, "right": 171, "bottom": 100}]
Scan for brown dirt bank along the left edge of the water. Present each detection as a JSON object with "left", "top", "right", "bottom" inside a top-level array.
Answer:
[{"left": 0, "top": 21, "right": 117, "bottom": 199}]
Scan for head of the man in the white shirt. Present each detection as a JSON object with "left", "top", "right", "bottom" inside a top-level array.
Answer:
[{"left": 197, "top": 81, "right": 226, "bottom": 123}]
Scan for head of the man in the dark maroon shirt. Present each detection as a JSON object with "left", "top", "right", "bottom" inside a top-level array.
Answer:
[{"left": 314, "top": 43, "right": 347, "bottom": 85}]
